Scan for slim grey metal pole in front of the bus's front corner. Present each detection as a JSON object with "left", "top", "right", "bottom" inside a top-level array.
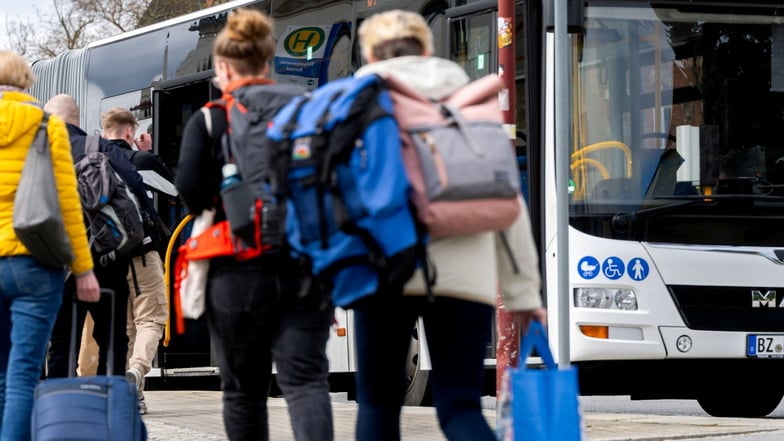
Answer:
[{"left": 554, "top": 0, "right": 582, "bottom": 368}]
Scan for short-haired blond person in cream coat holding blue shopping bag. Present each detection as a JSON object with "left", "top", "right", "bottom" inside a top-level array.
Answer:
[{"left": 353, "top": 10, "right": 546, "bottom": 441}]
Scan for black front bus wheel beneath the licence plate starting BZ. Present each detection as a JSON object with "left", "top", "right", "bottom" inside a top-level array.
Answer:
[{"left": 697, "top": 387, "right": 784, "bottom": 418}]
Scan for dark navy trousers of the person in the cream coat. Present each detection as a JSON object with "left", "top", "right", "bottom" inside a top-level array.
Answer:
[{"left": 352, "top": 290, "right": 496, "bottom": 441}]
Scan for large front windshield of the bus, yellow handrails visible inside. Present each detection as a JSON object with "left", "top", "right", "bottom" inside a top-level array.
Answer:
[{"left": 570, "top": 2, "right": 784, "bottom": 245}]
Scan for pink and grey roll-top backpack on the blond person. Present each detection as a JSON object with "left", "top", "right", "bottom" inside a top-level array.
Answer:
[{"left": 387, "top": 75, "right": 522, "bottom": 238}]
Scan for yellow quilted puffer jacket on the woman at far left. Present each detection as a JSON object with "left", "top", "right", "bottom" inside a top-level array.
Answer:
[{"left": 0, "top": 92, "right": 93, "bottom": 275}]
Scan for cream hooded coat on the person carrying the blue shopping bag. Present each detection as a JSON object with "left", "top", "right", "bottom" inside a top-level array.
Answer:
[{"left": 356, "top": 56, "right": 542, "bottom": 311}]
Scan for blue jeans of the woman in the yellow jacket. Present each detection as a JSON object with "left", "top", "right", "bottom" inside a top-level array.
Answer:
[{"left": 0, "top": 256, "right": 65, "bottom": 441}]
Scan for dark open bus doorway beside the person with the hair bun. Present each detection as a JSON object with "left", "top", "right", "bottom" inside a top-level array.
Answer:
[{"left": 153, "top": 70, "right": 220, "bottom": 377}]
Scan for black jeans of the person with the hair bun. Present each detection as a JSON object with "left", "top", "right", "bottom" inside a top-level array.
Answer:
[{"left": 207, "top": 260, "right": 334, "bottom": 441}]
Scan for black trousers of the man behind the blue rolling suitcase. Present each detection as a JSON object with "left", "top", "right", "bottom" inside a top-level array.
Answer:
[{"left": 47, "top": 256, "right": 130, "bottom": 378}]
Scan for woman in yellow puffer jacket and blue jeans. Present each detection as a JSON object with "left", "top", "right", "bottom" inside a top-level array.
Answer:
[{"left": 0, "top": 50, "right": 100, "bottom": 441}]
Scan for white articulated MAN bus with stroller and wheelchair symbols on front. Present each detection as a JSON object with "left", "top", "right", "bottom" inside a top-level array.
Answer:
[{"left": 32, "top": 0, "right": 784, "bottom": 417}]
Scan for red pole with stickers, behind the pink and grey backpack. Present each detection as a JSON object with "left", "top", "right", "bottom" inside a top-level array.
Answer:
[{"left": 495, "top": 0, "right": 520, "bottom": 396}]
